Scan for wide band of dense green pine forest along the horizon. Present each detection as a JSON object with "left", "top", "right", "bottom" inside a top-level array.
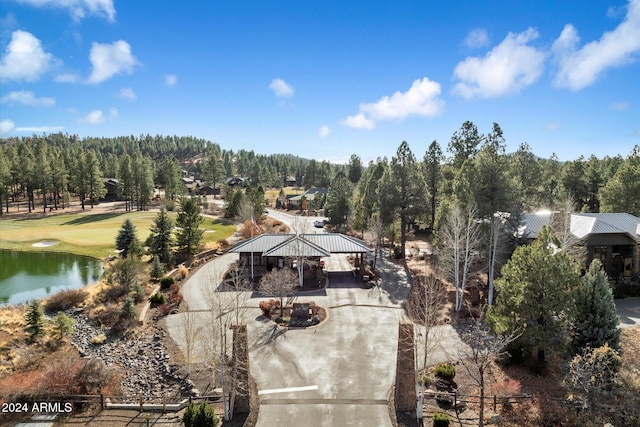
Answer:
[{"left": 0, "top": 121, "right": 640, "bottom": 221}]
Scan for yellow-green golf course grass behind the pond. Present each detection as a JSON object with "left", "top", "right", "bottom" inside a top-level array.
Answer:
[{"left": 0, "top": 212, "right": 236, "bottom": 258}]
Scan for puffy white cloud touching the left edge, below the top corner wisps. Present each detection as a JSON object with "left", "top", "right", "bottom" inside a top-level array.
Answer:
[{"left": 0, "top": 30, "right": 55, "bottom": 82}]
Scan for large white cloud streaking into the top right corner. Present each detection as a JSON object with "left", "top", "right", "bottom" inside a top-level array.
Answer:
[{"left": 551, "top": 0, "right": 640, "bottom": 91}]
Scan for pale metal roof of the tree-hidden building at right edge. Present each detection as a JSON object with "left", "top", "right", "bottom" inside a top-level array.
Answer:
[{"left": 519, "top": 213, "right": 640, "bottom": 239}]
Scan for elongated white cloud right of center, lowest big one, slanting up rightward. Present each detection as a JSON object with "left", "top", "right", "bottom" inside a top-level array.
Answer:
[{"left": 340, "top": 77, "right": 444, "bottom": 129}]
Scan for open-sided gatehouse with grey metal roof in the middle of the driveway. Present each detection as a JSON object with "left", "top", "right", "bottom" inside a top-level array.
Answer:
[{"left": 230, "top": 233, "right": 371, "bottom": 280}]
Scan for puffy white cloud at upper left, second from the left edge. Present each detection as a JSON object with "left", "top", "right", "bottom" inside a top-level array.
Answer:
[{"left": 89, "top": 40, "right": 138, "bottom": 83}]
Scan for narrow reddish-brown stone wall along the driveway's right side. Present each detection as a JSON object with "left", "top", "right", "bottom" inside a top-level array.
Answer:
[{"left": 395, "top": 323, "right": 416, "bottom": 412}]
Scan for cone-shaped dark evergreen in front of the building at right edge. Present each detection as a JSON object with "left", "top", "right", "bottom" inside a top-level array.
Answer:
[{"left": 571, "top": 260, "right": 620, "bottom": 353}]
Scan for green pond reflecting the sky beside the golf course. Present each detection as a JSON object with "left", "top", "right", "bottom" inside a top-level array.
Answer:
[{"left": 0, "top": 250, "right": 102, "bottom": 305}]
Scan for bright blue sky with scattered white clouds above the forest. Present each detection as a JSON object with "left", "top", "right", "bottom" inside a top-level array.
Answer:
[{"left": 0, "top": 0, "right": 640, "bottom": 162}]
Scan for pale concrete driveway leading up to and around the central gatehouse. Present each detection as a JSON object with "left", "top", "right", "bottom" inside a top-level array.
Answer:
[{"left": 167, "top": 212, "right": 468, "bottom": 427}]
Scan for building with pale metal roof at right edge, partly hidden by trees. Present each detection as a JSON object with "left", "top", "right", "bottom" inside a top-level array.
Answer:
[{"left": 519, "top": 213, "right": 640, "bottom": 278}]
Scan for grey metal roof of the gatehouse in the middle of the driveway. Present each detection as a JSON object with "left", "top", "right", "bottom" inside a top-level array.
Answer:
[{"left": 231, "top": 233, "right": 371, "bottom": 257}]
